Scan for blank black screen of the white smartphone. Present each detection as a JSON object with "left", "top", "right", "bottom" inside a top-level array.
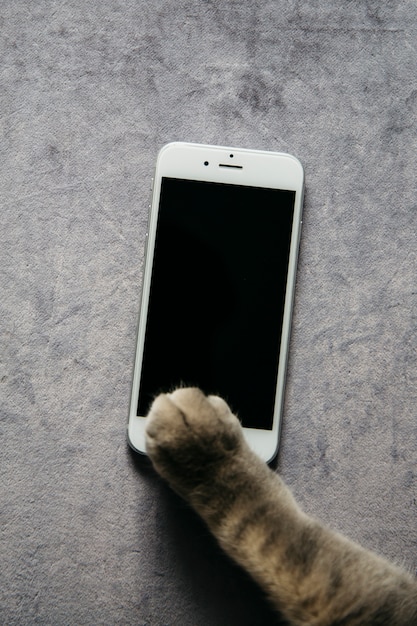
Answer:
[{"left": 138, "top": 178, "right": 295, "bottom": 429}]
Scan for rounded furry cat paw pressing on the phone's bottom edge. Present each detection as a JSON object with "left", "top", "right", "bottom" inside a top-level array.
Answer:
[{"left": 146, "top": 388, "right": 243, "bottom": 493}]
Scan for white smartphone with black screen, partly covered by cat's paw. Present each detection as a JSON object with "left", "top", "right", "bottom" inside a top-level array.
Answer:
[{"left": 128, "top": 143, "right": 304, "bottom": 462}]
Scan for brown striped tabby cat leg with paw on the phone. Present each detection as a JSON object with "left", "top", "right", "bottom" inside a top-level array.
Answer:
[{"left": 147, "top": 389, "right": 417, "bottom": 626}]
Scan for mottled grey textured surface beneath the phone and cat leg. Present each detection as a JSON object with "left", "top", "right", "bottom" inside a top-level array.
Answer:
[{"left": 0, "top": 0, "right": 417, "bottom": 626}]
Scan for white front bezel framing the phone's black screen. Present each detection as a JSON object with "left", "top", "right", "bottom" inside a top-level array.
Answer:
[{"left": 128, "top": 142, "right": 304, "bottom": 462}]
